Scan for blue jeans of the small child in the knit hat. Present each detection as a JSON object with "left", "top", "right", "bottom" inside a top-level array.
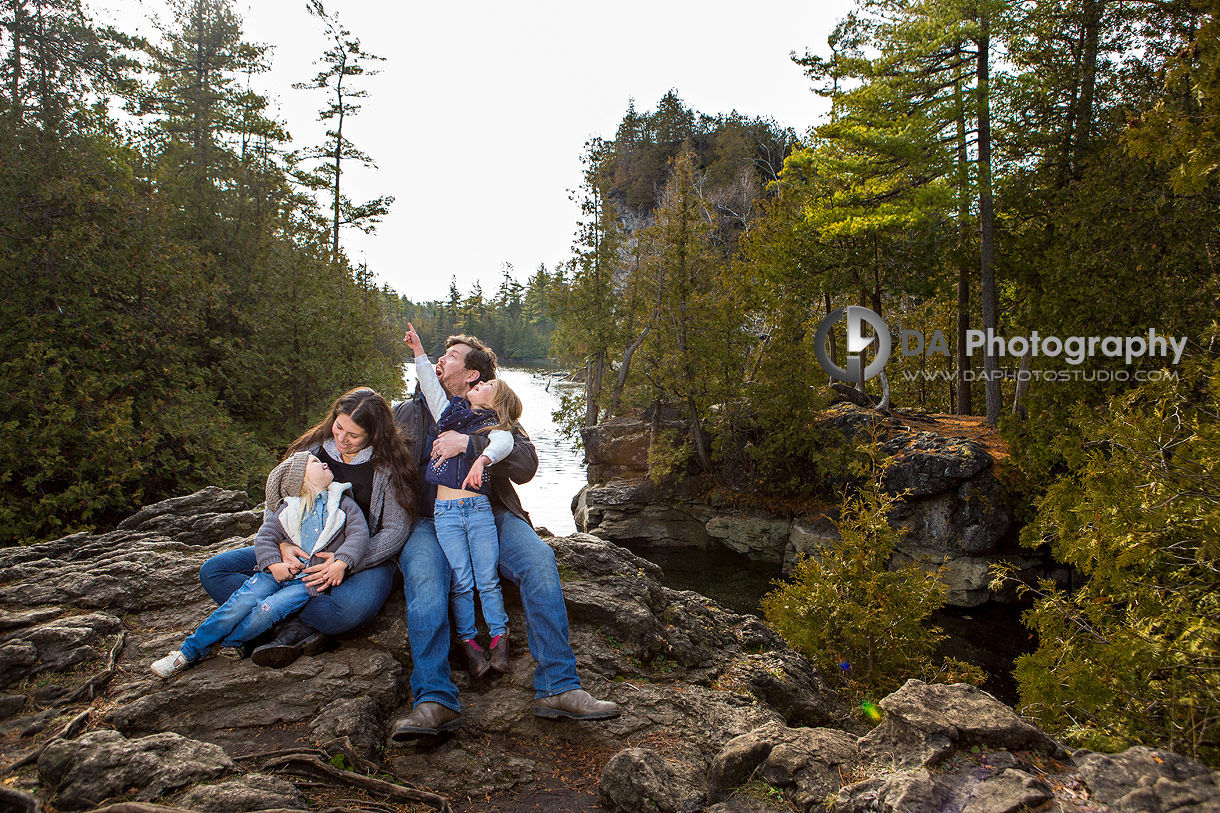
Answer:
[{"left": 178, "top": 573, "right": 309, "bottom": 660}]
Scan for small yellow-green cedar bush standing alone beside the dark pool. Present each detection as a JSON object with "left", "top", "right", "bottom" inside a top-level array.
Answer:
[{"left": 763, "top": 452, "right": 961, "bottom": 697}]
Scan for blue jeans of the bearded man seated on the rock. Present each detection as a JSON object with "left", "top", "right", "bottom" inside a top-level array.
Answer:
[{"left": 398, "top": 508, "right": 581, "bottom": 712}]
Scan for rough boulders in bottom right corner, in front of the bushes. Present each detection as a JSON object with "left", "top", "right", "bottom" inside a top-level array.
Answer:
[{"left": 601, "top": 680, "right": 1220, "bottom": 813}]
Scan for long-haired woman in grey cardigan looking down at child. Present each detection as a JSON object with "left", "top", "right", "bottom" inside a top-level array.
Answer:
[{"left": 192, "top": 387, "right": 420, "bottom": 668}]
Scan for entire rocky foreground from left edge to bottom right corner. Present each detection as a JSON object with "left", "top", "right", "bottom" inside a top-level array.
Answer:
[{"left": 0, "top": 488, "right": 1220, "bottom": 813}]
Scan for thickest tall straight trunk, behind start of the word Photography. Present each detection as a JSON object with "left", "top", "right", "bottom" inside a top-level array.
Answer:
[{"left": 977, "top": 15, "right": 1002, "bottom": 426}]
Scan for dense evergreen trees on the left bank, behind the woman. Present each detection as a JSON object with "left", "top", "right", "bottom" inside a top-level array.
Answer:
[{"left": 0, "top": 0, "right": 403, "bottom": 543}]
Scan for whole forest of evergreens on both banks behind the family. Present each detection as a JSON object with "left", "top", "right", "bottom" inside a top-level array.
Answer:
[{"left": 0, "top": 0, "right": 1220, "bottom": 764}]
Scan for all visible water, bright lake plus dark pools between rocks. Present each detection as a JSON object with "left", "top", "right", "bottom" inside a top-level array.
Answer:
[{"left": 404, "top": 364, "right": 1033, "bottom": 704}]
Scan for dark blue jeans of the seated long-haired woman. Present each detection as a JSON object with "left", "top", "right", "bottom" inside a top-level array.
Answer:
[{"left": 199, "top": 547, "right": 397, "bottom": 635}]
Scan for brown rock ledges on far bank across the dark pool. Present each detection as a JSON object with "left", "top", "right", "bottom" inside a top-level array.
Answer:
[{"left": 572, "top": 403, "right": 1065, "bottom": 607}]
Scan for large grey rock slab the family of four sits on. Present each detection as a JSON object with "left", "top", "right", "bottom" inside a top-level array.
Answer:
[{"left": 0, "top": 490, "right": 856, "bottom": 811}]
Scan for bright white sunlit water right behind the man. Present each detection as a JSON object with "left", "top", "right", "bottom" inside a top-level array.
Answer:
[{"left": 403, "top": 363, "right": 586, "bottom": 536}]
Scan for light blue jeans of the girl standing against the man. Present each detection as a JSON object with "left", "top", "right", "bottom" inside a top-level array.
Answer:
[{"left": 433, "top": 494, "right": 509, "bottom": 641}]
